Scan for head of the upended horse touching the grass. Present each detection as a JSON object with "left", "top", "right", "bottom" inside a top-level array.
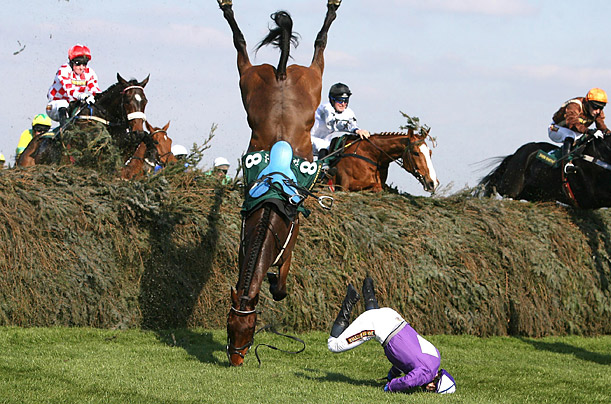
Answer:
[{"left": 226, "top": 288, "right": 259, "bottom": 366}]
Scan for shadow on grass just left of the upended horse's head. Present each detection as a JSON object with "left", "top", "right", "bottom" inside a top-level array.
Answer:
[{"left": 156, "top": 329, "right": 229, "bottom": 367}]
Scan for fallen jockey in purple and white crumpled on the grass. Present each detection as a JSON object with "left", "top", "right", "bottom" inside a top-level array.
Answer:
[{"left": 327, "top": 277, "right": 456, "bottom": 394}]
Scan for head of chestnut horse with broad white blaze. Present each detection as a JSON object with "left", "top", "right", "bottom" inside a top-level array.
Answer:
[{"left": 401, "top": 128, "right": 439, "bottom": 192}]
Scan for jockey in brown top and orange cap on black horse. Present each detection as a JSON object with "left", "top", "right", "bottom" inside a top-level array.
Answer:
[{"left": 548, "top": 88, "right": 611, "bottom": 173}]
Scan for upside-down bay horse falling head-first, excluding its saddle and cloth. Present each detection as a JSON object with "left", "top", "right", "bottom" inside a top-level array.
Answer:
[{"left": 217, "top": 0, "right": 341, "bottom": 366}]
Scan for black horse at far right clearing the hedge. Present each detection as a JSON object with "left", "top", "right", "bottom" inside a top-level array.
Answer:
[{"left": 479, "top": 134, "right": 611, "bottom": 209}]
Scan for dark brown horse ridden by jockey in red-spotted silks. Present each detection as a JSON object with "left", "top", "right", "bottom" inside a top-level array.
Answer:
[{"left": 17, "top": 73, "right": 149, "bottom": 167}]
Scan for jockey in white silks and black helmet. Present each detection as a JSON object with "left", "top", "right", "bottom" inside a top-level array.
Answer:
[{"left": 310, "top": 83, "right": 369, "bottom": 165}]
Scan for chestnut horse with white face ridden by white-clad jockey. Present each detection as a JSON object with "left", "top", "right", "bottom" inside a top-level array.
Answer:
[{"left": 330, "top": 128, "right": 439, "bottom": 192}]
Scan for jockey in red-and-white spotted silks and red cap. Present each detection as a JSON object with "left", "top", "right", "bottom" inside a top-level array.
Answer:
[{"left": 47, "top": 44, "right": 101, "bottom": 126}]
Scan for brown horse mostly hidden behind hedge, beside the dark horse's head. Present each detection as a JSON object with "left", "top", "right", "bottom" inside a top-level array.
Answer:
[{"left": 121, "top": 118, "right": 176, "bottom": 180}]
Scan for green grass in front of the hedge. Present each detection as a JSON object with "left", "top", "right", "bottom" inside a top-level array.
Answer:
[{"left": 0, "top": 327, "right": 611, "bottom": 404}]
